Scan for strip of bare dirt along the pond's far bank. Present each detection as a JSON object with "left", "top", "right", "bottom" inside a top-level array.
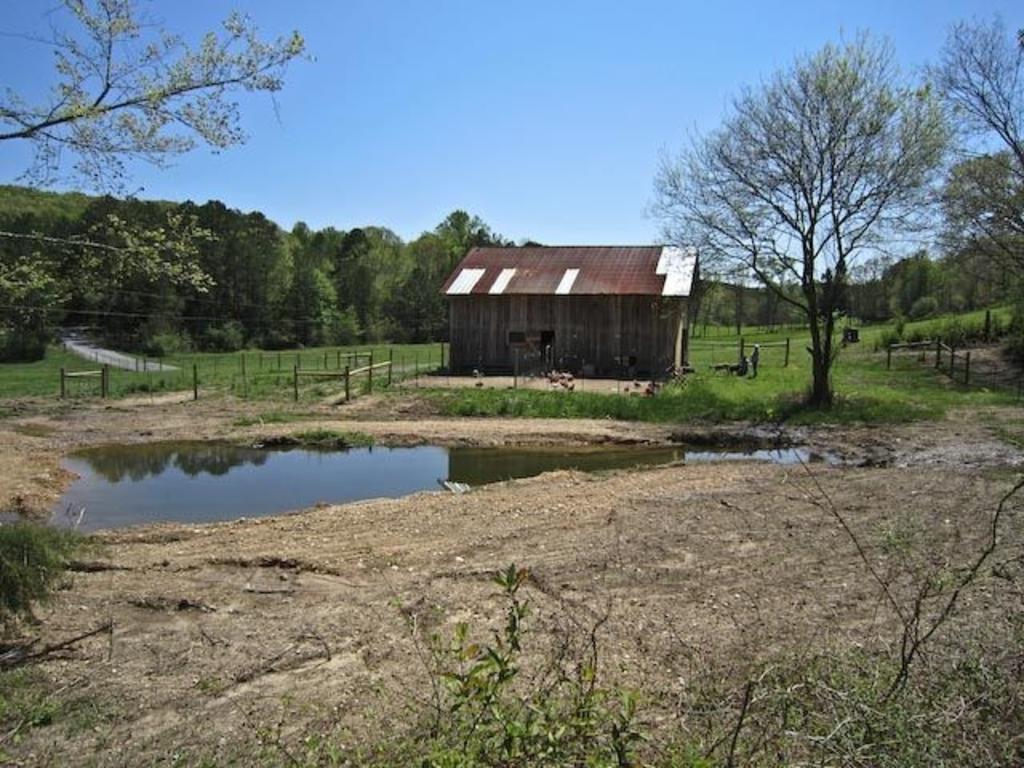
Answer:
[{"left": 0, "top": 395, "right": 1024, "bottom": 520}]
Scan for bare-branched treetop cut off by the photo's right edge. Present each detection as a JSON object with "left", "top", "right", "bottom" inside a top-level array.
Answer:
[{"left": 932, "top": 18, "right": 1024, "bottom": 274}]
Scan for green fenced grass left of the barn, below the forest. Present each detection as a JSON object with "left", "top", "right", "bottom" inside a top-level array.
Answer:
[{"left": 0, "top": 344, "right": 441, "bottom": 400}]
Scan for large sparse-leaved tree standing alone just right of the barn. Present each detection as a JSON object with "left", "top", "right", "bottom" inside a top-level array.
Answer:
[{"left": 655, "top": 36, "right": 947, "bottom": 407}]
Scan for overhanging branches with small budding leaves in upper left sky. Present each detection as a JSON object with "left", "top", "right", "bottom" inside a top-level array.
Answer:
[{"left": 0, "top": 0, "right": 305, "bottom": 187}]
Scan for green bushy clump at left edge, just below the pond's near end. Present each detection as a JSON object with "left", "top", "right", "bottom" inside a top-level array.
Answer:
[{"left": 0, "top": 522, "right": 84, "bottom": 618}]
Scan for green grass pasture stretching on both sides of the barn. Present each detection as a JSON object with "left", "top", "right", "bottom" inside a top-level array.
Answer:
[{"left": 0, "top": 308, "right": 1020, "bottom": 423}]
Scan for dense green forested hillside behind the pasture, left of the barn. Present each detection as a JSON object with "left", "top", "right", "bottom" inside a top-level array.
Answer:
[{"left": 0, "top": 186, "right": 506, "bottom": 359}]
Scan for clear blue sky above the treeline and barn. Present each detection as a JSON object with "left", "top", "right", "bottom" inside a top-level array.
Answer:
[{"left": 0, "top": 0, "right": 1011, "bottom": 244}]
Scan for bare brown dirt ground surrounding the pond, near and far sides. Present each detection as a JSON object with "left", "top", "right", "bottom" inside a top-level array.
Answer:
[{"left": 0, "top": 397, "right": 1024, "bottom": 765}]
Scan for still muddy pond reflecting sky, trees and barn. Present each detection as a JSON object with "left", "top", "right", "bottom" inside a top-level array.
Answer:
[{"left": 53, "top": 442, "right": 816, "bottom": 530}]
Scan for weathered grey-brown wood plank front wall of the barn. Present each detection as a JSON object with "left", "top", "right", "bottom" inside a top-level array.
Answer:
[{"left": 449, "top": 295, "right": 686, "bottom": 376}]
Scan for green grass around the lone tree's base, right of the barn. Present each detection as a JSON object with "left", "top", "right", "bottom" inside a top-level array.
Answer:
[{"left": 425, "top": 313, "right": 1017, "bottom": 424}]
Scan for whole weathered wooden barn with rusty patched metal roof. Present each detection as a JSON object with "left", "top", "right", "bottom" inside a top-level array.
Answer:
[{"left": 441, "top": 246, "right": 698, "bottom": 377}]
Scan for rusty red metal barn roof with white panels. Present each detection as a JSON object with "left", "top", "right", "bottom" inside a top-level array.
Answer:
[{"left": 441, "top": 246, "right": 696, "bottom": 297}]
